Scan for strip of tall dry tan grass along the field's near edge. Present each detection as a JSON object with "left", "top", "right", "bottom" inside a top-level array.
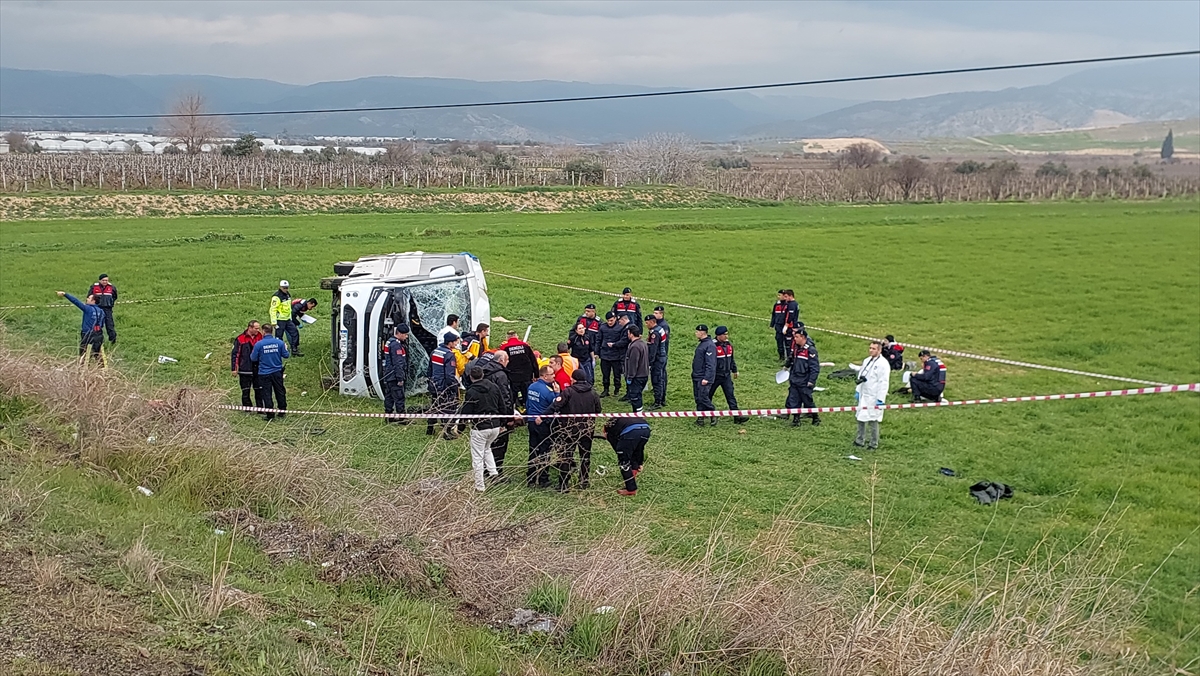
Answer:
[{"left": 0, "top": 346, "right": 1146, "bottom": 676}]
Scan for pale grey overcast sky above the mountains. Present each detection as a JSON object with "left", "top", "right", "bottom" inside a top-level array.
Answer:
[{"left": 0, "top": 0, "right": 1200, "bottom": 98}]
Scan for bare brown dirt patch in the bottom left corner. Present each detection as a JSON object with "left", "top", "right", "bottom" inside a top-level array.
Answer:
[{"left": 0, "top": 549, "right": 205, "bottom": 676}]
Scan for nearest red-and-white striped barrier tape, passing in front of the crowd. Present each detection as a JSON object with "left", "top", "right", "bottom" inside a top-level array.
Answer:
[{"left": 217, "top": 383, "right": 1200, "bottom": 419}]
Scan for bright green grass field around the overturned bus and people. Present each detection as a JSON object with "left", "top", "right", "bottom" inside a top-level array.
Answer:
[{"left": 0, "top": 196, "right": 1200, "bottom": 664}]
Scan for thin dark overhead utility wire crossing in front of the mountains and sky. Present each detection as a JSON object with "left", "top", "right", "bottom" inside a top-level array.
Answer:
[{"left": 0, "top": 49, "right": 1200, "bottom": 120}]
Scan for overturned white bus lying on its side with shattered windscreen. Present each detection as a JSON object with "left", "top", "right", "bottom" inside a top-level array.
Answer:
[{"left": 322, "top": 251, "right": 491, "bottom": 399}]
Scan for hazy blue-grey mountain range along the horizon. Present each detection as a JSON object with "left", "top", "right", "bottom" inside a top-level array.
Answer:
[{"left": 0, "top": 58, "right": 1200, "bottom": 143}]
